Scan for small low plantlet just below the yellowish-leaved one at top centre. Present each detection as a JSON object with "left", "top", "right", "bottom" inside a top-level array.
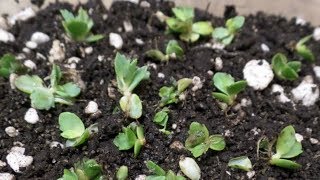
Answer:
[{"left": 146, "top": 40, "right": 184, "bottom": 62}]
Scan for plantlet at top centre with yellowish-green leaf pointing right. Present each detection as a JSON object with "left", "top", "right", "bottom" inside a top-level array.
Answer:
[{"left": 166, "top": 7, "right": 213, "bottom": 42}]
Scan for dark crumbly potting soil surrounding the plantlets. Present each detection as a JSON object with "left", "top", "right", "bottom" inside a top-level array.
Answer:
[{"left": 0, "top": 1, "right": 320, "bottom": 180}]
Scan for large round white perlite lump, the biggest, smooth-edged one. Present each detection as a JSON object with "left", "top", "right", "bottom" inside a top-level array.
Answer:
[{"left": 243, "top": 59, "right": 274, "bottom": 90}]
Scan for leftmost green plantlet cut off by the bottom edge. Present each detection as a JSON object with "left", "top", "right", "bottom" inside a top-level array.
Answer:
[{"left": 58, "top": 158, "right": 105, "bottom": 180}]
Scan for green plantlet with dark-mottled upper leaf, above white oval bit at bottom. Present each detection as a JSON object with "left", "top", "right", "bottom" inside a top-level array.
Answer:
[{"left": 185, "top": 122, "right": 226, "bottom": 158}]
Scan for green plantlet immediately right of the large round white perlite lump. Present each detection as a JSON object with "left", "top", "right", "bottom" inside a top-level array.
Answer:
[{"left": 272, "top": 53, "right": 301, "bottom": 80}]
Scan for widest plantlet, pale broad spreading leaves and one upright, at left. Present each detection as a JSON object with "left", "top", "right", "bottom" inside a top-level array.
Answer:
[{"left": 14, "top": 65, "right": 81, "bottom": 110}]
